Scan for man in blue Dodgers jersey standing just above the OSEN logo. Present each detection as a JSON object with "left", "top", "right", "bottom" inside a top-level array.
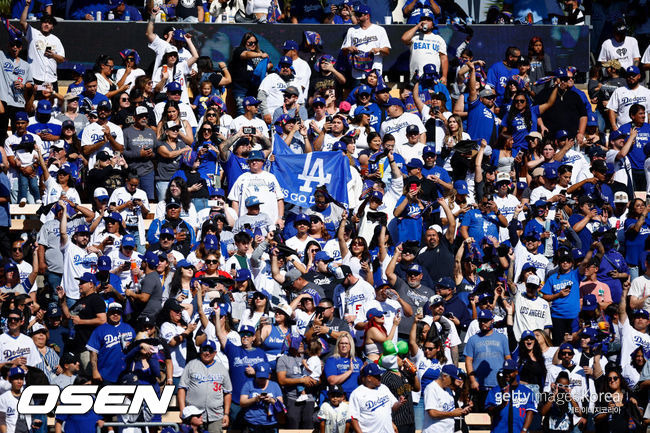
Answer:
[{"left": 86, "top": 302, "right": 135, "bottom": 385}]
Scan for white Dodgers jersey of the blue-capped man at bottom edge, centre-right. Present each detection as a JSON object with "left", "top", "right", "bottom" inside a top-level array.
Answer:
[{"left": 350, "top": 384, "right": 397, "bottom": 433}]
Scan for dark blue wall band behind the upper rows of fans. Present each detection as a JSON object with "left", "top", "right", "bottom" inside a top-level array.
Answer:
[{"left": 0, "top": 21, "right": 590, "bottom": 82}]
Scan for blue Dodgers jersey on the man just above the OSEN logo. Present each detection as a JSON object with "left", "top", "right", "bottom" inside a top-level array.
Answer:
[{"left": 86, "top": 322, "right": 135, "bottom": 382}]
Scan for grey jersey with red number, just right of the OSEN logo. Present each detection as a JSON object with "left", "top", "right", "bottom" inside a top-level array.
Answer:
[{"left": 178, "top": 358, "right": 232, "bottom": 422}]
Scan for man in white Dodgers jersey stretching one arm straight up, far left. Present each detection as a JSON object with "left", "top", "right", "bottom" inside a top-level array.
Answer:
[{"left": 58, "top": 200, "right": 101, "bottom": 306}]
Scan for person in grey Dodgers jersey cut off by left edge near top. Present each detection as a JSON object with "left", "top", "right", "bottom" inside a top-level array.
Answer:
[{"left": 0, "top": 35, "right": 34, "bottom": 143}]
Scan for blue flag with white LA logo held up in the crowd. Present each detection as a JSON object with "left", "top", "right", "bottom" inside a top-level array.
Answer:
[{"left": 271, "top": 152, "right": 352, "bottom": 207}]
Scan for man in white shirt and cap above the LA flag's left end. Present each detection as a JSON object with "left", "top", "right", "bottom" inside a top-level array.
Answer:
[{"left": 257, "top": 56, "right": 304, "bottom": 124}]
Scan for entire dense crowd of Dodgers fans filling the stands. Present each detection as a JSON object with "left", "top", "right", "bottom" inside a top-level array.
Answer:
[{"left": 0, "top": 0, "right": 650, "bottom": 433}]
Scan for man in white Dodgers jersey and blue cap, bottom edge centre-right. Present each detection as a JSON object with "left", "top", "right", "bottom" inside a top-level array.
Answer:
[{"left": 350, "top": 363, "right": 406, "bottom": 433}]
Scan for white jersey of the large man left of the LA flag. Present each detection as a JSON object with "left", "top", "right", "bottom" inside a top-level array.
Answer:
[{"left": 228, "top": 171, "right": 284, "bottom": 221}]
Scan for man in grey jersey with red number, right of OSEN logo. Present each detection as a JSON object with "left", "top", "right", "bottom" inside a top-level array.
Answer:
[{"left": 178, "top": 340, "right": 232, "bottom": 433}]
